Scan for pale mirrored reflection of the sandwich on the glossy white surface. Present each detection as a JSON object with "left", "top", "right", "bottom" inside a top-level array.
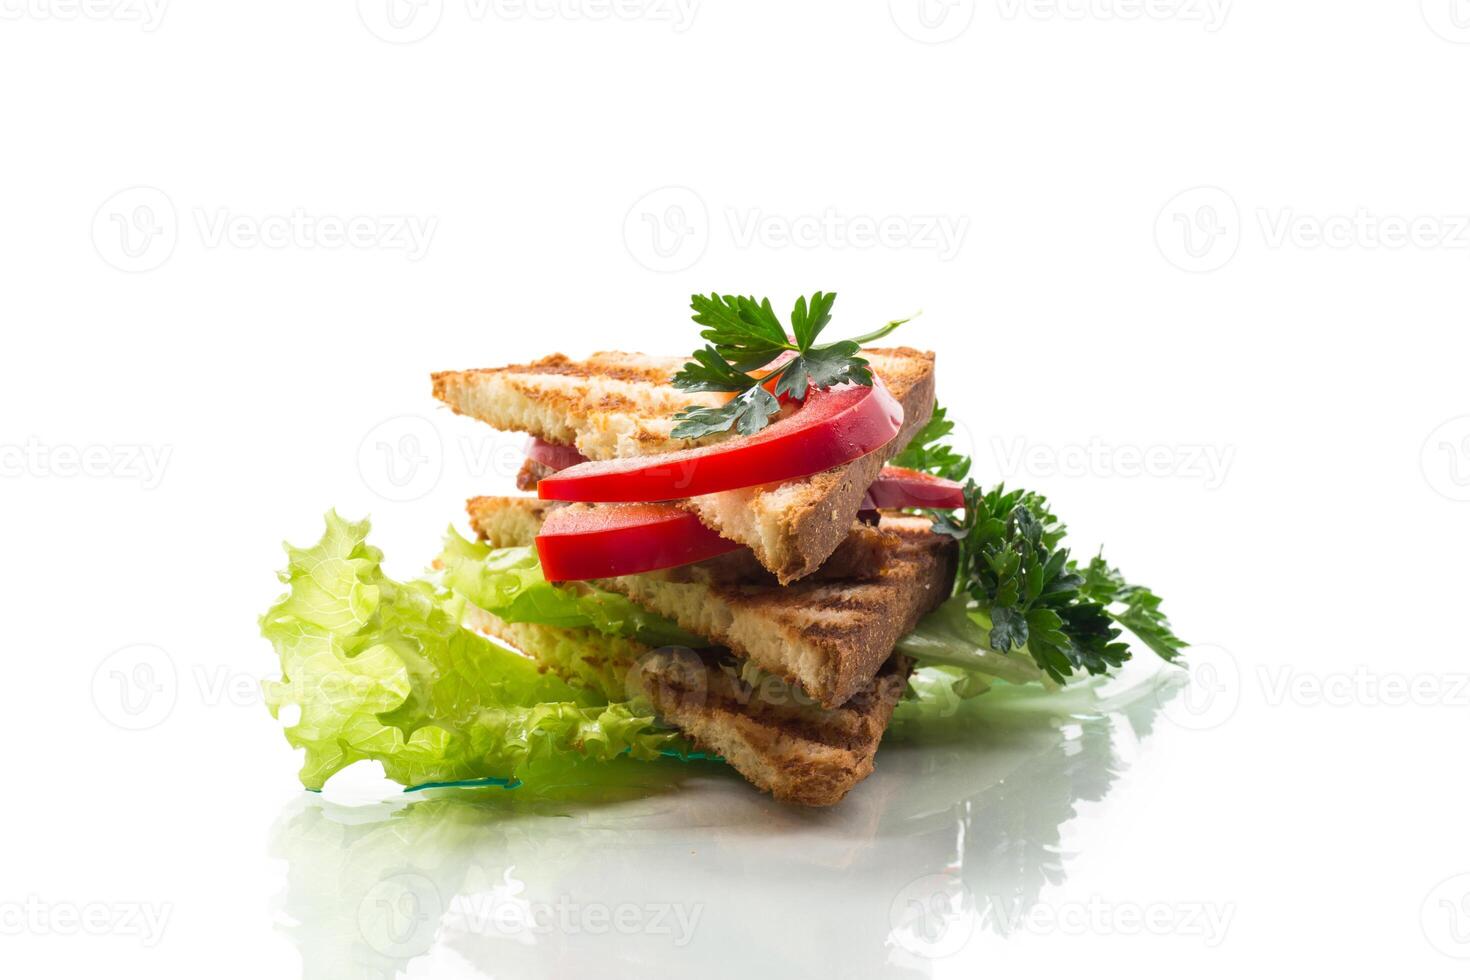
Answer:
[{"left": 275, "top": 667, "right": 1181, "bottom": 980}]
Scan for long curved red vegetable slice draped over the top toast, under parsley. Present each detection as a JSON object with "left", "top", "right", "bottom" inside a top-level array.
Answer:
[{"left": 537, "top": 379, "right": 904, "bottom": 501}]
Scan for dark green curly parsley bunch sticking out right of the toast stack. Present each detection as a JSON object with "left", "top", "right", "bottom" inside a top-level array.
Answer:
[{"left": 933, "top": 480, "right": 1186, "bottom": 683}]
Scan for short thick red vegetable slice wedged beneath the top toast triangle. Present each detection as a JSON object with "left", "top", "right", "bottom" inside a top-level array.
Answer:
[{"left": 537, "top": 504, "right": 744, "bottom": 582}]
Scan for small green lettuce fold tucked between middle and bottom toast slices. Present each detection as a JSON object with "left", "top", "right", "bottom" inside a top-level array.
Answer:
[{"left": 440, "top": 527, "right": 710, "bottom": 648}]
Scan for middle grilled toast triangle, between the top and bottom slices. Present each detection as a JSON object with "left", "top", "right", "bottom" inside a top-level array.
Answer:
[{"left": 469, "top": 497, "right": 956, "bottom": 708}]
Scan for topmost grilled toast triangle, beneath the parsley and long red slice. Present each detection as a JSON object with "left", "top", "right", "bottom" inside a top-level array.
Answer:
[{"left": 434, "top": 347, "right": 933, "bottom": 585}]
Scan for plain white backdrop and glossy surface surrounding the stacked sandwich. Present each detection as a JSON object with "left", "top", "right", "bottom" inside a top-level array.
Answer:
[{"left": 0, "top": 0, "right": 1470, "bottom": 977}]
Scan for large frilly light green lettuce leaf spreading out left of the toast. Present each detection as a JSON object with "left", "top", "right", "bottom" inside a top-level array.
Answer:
[{"left": 260, "top": 513, "right": 673, "bottom": 789}]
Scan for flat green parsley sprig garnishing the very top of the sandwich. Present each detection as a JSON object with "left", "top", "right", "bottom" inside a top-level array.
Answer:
[{"left": 673, "top": 292, "right": 908, "bottom": 439}]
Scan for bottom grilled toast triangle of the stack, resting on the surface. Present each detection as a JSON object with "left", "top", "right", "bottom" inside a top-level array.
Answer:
[{"left": 469, "top": 608, "right": 910, "bottom": 807}]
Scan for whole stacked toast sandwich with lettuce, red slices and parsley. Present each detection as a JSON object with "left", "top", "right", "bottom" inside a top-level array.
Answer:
[{"left": 262, "top": 292, "right": 1183, "bottom": 807}]
